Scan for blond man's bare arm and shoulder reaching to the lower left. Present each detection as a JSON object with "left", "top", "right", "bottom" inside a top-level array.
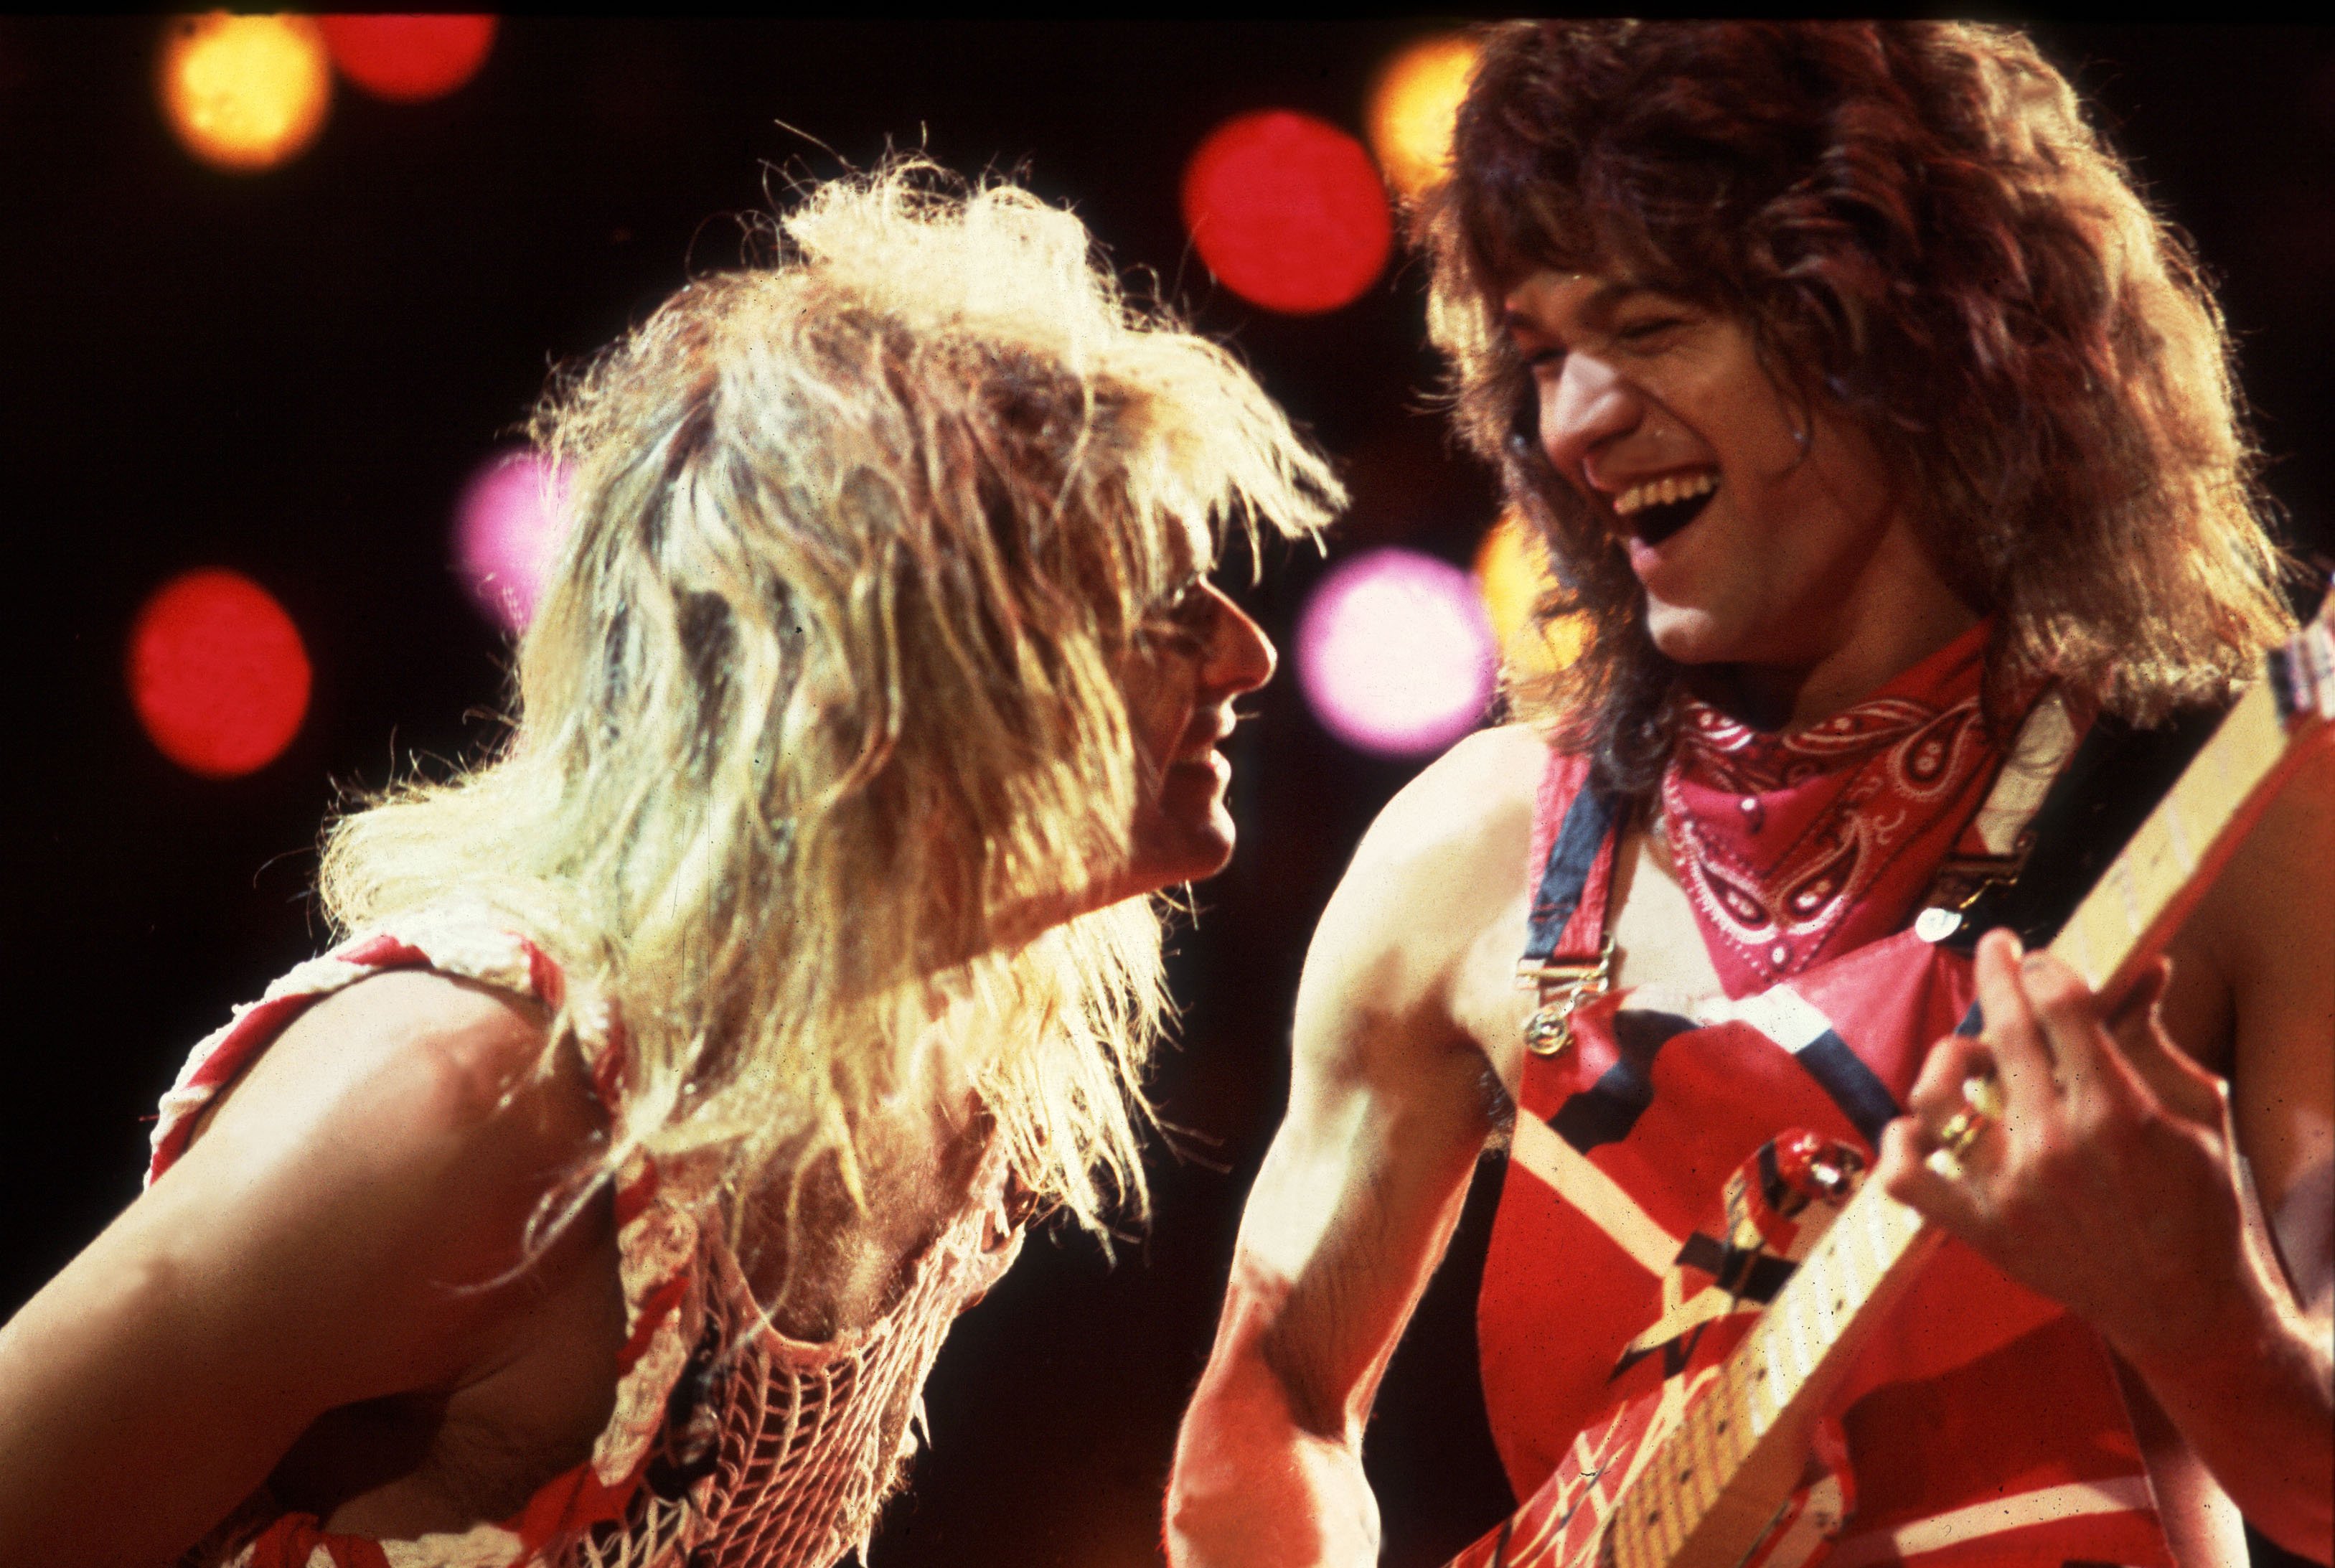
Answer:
[{"left": 0, "top": 975, "right": 611, "bottom": 1568}]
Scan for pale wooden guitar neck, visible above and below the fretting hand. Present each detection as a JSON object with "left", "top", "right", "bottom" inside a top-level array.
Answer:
[{"left": 1609, "top": 598, "right": 2335, "bottom": 1568}]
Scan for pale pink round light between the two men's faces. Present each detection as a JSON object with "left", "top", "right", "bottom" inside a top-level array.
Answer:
[{"left": 1298, "top": 549, "right": 1495, "bottom": 755}]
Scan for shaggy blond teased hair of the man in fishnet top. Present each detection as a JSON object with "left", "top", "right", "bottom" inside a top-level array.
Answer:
[{"left": 322, "top": 161, "right": 1343, "bottom": 1236}]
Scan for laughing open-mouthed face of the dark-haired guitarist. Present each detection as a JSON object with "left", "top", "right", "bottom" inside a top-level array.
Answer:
[{"left": 1504, "top": 268, "right": 1896, "bottom": 668}]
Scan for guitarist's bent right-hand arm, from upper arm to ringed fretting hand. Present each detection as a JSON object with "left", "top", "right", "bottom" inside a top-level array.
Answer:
[{"left": 1879, "top": 750, "right": 2335, "bottom": 1561}]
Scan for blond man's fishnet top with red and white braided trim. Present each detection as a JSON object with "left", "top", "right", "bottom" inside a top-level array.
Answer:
[{"left": 147, "top": 909, "right": 1020, "bottom": 1568}]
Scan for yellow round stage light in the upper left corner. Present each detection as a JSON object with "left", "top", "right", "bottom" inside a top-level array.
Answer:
[{"left": 161, "top": 11, "right": 332, "bottom": 173}]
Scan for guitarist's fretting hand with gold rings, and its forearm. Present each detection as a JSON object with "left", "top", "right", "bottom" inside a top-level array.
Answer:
[{"left": 1875, "top": 920, "right": 2335, "bottom": 1561}]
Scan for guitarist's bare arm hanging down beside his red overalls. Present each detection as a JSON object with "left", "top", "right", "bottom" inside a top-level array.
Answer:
[{"left": 1168, "top": 733, "right": 1538, "bottom": 1566}]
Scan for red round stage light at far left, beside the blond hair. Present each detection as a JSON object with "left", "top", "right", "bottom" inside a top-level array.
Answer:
[{"left": 128, "top": 568, "right": 309, "bottom": 778}]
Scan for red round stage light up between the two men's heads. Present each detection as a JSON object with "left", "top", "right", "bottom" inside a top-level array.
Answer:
[{"left": 1184, "top": 110, "right": 1394, "bottom": 316}]
